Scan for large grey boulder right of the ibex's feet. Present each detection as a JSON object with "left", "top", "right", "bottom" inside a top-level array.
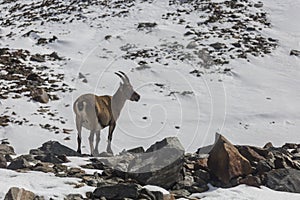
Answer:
[{"left": 93, "top": 137, "right": 184, "bottom": 189}]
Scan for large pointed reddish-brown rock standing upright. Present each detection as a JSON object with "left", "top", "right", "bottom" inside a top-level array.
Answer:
[{"left": 208, "top": 134, "right": 252, "bottom": 184}]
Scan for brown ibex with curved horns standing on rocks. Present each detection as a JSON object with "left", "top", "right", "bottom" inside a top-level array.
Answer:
[{"left": 73, "top": 71, "right": 140, "bottom": 156}]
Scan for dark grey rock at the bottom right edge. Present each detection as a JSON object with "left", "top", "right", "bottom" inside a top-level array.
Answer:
[{"left": 266, "top": 168, "right": 300, "bottom": 193}]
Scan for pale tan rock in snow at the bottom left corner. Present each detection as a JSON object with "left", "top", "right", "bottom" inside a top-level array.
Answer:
[{"left": 4, "top": 187, "right": 35, "bottom": 200}]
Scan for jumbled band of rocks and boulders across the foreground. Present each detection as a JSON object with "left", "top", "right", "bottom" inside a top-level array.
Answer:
[{"left": 0, "top": 134, "right": 300, "bottom": 200}]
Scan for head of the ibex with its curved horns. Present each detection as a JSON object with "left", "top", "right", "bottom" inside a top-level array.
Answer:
[{"left": 115, "top": 71, "right": 140, "bottom": 101}]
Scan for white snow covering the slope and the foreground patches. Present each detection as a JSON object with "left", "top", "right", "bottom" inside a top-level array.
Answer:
[{"left": 0, "top": 0, "right": 300, "bottom": 199}]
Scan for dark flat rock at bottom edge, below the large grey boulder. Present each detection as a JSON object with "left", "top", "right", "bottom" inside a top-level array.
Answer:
[{"left": 93, "top": 184, "right": 140, "bottom": 200}]
